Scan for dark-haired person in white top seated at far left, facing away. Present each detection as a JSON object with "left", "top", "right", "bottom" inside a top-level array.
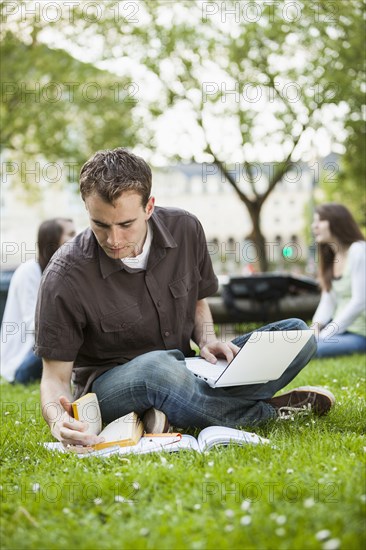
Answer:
[{"left": 1, "top": 218, "right": 75, "bottom": 384}]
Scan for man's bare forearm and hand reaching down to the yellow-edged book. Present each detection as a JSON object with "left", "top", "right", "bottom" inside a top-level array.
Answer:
[{"left": 41, "top": 359, "right": 101, "bottom": 447}]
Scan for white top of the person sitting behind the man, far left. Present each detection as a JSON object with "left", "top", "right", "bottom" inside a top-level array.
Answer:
[{"left": 0, "top": 260, "right": 42, "bottom": 382}]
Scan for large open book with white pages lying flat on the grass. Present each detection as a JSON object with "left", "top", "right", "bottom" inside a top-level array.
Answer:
[{"left": 44, "top": 426, "right": 269, "bottom": 458}]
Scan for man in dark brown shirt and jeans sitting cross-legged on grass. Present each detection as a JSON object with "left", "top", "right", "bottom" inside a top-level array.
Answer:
[{"left": 35, "top": 148, "right": 334, "bottom": 452}]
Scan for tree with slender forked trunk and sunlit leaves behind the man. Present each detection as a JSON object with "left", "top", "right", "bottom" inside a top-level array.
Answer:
[{"left": 96, "top": 0, "right": 364, "bottom": 270}]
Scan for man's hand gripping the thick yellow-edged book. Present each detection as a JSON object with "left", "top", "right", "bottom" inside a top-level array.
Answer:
[{"left": 51, "top": 396, "right": 103, "bottom": 453}]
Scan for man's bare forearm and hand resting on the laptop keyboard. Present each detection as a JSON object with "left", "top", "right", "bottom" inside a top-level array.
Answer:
[{"left": 193, "top": 299, "right": 240, "bottom": 363}]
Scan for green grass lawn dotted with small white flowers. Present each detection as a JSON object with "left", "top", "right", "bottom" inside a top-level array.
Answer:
[{"left": 0, "top": 356, "right": 366, "bottom": 550}]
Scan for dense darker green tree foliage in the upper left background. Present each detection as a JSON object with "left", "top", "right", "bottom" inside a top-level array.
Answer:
[{"left": 0, "top": 2, "right": 135, "bottom": 198}]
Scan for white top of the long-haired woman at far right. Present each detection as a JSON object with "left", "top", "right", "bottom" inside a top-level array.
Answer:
[{"left": 313, "top": 241, "right": 366, "bottom": 337}]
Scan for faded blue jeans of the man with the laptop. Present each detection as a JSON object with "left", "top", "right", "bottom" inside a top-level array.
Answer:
[{"left": 92, "top": 319, "right": 316, "bottom": 428}]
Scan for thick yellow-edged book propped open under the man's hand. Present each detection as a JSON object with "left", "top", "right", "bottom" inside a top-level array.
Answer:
[{"left": 72, "top": 393, "right": 144, "bottom": 450}]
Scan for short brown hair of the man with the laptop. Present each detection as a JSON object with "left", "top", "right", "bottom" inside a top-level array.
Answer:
[{"left": 80, "top": 147, "right": 152, "bottom": 207}]
